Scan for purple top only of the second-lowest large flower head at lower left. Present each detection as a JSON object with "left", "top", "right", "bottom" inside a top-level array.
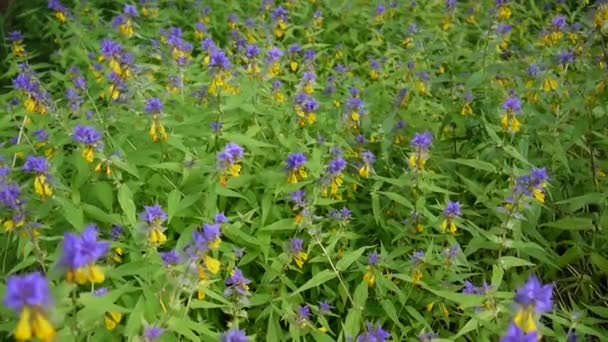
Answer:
[{"left": 59, "top": 224, "right": 110, "bottom": 270}]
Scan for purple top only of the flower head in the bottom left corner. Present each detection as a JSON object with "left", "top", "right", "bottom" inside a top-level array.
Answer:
[{"left": 4, "top": 272, "right": 52, "bottom": 311}]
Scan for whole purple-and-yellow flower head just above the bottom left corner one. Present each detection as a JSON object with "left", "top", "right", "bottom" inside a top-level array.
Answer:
[{"left": 60, "top": 224, "right": 110, "bottom": 285}]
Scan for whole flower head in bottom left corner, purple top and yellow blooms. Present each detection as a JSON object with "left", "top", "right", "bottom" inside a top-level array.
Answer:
[{"left": 4, "top": 272, "right": 55, "bottom": 341}]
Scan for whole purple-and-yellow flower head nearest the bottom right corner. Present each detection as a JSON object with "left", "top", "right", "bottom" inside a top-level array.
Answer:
[{"left": 513, "top": 276, "right": 553, "bottom": 334}]
